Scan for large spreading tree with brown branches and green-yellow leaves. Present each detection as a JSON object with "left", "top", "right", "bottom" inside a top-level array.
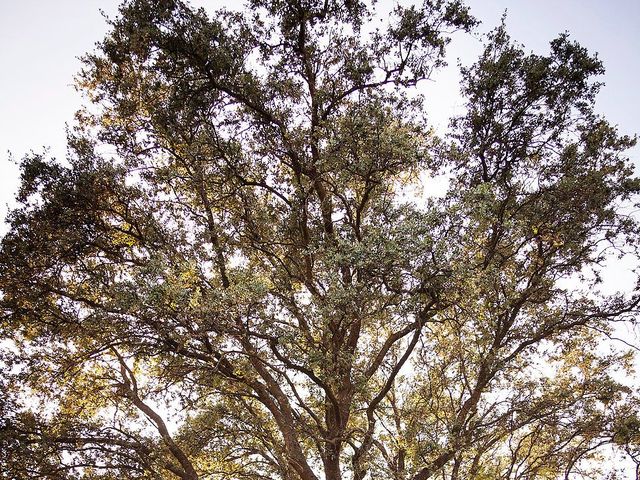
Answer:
[{"left": 0, "top": 0, "right": 640, "bottom": 480}]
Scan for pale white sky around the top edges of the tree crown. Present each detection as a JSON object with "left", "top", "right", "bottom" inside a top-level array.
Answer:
[{"left": 0, "top": 0, "right": 640, "bottom": 220}]
